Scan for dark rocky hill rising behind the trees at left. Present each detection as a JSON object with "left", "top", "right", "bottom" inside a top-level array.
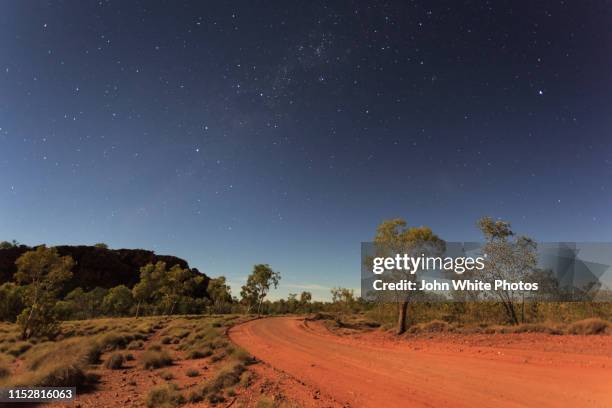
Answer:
[{"left": 0, "top": 245, "right": 210, "bottom": 297}]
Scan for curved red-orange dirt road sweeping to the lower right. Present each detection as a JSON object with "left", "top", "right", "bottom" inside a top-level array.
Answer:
[{"left": 229, "top": 317, "right": 612, "bottom": 408}]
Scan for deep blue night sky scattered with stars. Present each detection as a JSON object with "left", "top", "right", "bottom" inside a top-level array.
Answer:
[{"left": 0, "top": 0, "right": 612, "bottom": 299}]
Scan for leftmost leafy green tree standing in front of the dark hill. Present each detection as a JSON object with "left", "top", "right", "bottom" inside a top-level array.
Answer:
[{"left": 15, "top": 245, "right": 74, "bottom": 339}]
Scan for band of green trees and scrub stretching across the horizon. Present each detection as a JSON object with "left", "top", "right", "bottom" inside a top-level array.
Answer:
[{"left": 0, "top": 212, "right": 609, "bottom": 338}]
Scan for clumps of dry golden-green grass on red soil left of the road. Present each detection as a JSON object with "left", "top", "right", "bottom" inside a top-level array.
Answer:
[{"left": 0, "top": 316, "right": 252, "bottom": 400}]
